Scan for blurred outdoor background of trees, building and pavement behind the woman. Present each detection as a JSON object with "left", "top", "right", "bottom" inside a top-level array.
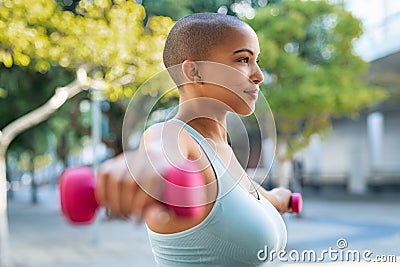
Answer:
[{"left": 0, "top": 0, "right": 400, "bottom": 267}]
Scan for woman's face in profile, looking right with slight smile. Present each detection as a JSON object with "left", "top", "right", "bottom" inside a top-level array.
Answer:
[{"left": 195, "top": 26, "right": 264, "bottom": 116}]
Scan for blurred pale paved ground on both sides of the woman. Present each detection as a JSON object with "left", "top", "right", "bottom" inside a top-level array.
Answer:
[{"left": 9, "top": 188, "right": 400, "bottom": 267}]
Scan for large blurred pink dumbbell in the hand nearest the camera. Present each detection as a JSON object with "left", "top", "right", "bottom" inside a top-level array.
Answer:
[{"left": 60, "top": 160, "right": 206, "bottom": 224}]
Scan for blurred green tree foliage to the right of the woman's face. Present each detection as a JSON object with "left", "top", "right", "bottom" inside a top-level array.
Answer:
[{"left": 249, "top": 0, "right": 386, "bottom": 157}]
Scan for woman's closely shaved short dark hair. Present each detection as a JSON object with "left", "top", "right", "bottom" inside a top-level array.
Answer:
[{"left": 163, "top": 13, "right": 247, "bottom": 82}]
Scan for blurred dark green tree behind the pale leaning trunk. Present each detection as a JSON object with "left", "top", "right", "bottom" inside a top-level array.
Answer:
[{"left": 0, "top": 66, "right": 73, "bottom": 203}]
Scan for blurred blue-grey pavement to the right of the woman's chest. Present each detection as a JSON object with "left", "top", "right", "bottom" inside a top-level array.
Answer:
[{"left": 286, "top": 191, "right": 400, "bottom": 267}]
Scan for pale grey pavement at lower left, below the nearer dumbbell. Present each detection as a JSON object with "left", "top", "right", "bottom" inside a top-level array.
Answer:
[{"left": 9, "top": 189, "right": 156, "bottom": 267}]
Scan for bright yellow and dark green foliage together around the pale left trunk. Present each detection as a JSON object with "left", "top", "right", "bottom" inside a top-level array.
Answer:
[{"left": 0, "top": 0, "right": 173, "bottom": 164}]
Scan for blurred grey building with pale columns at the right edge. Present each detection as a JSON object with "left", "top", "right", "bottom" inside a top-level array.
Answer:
[{"left": 299, "top": 0, "right": 400, "bottom": 193}]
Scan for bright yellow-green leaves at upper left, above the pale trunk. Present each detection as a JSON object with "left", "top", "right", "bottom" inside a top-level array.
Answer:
[{"left": 0, "top": 0, "right": 173, "bottom": 101}]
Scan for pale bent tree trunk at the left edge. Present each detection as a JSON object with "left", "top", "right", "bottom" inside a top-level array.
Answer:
[{"left": 0, "top": 81, "right": 86, "bottom": 267}]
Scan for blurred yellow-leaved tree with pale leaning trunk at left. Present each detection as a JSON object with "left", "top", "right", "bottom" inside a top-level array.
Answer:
[{"left": 0, "top": 0, "right": 172, "bottom": 266}]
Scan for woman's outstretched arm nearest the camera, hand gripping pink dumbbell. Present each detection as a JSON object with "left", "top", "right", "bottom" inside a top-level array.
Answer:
[{"left": 95, "top": 123, "right": 217, "bottom": 233}]
